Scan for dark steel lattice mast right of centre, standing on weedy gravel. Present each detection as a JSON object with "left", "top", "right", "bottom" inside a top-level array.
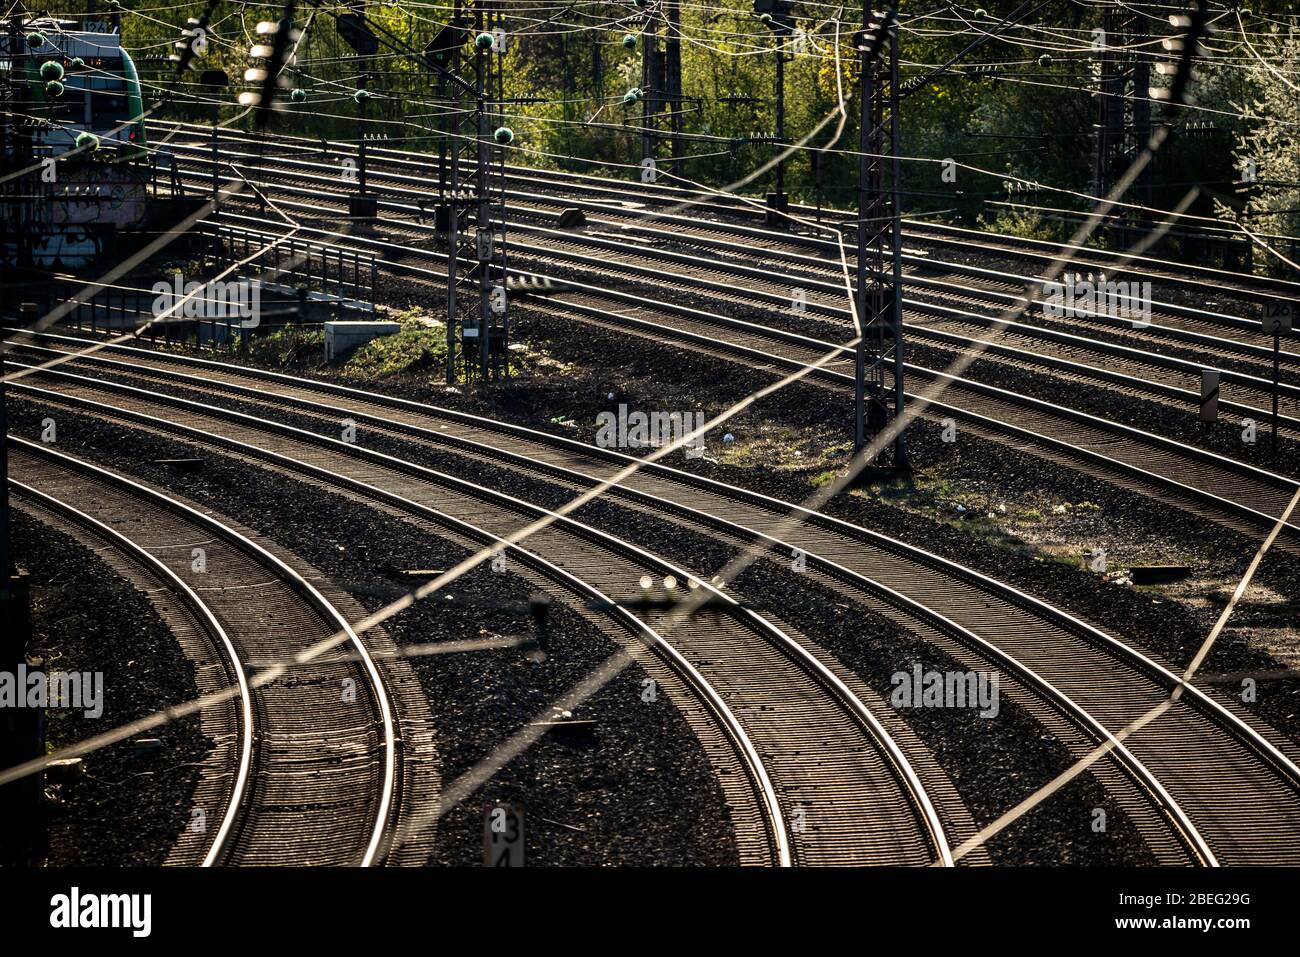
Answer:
[{"left": 853, "top": 0, "right": 909, "bottom": 472}]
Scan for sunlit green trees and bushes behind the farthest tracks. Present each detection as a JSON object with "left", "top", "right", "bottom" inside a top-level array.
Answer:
[{"left": 27, "top": 0, "right": 1279, "bottom": 239}]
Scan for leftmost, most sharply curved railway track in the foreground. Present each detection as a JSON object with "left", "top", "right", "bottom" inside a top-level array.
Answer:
[{"left": 9, "top": 438, "right": 398, "bottom": 866}]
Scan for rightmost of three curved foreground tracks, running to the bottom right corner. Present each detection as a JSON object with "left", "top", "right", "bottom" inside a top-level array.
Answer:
[{"left": 16, "top": 337, "right": 1296, "bottom": 862}]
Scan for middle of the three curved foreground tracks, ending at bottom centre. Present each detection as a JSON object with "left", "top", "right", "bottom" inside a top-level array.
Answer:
[{"left": 0, "top": 351, "right": 952, "bottom": 865}]
